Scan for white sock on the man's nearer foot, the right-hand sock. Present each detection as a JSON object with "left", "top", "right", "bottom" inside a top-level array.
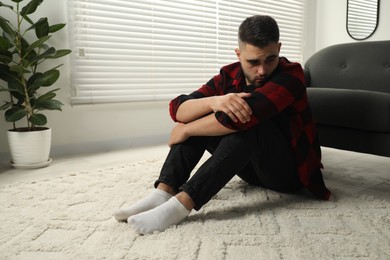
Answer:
[{"left": 127, "top": 197, "right": 191, "bottom": 234}]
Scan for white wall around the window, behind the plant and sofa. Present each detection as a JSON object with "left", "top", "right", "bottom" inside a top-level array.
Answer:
[{"left": 0, "top": 0, "right": 390, "bottom": 161}]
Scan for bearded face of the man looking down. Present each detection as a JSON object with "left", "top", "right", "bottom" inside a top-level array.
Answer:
[{"left": 235, "top": 43, "right": 282, "bottom": 87}]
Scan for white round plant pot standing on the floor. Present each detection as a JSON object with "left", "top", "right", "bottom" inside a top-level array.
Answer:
[{"left": 8, "top": 128, "right": 51, "bottom": 168}]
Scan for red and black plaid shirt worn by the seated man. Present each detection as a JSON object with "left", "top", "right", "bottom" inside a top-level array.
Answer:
[{"left": 170, "top": 57, "right": 330, "bottom": 199}]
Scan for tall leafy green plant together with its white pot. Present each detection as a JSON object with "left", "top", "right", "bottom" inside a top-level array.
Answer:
[{"left": 0, "top": 0, "right": 71, "bottom": 168}]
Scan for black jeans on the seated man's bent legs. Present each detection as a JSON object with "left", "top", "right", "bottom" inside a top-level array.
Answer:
[{"left": 155, "top": 121, "right": 302, "bottom": 210}]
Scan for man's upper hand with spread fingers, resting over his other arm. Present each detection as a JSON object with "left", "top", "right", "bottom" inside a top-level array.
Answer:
[{"left": 211, "top": 92, "right": 252, "bottom": 123}]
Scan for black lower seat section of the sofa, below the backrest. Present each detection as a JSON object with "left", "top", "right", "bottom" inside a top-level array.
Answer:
[{"left": 307, "top": 87, "right": 390, "bottom": 132}]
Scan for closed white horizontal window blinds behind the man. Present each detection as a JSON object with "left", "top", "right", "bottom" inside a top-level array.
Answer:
[{"left": 68, "top": 0, "right": 304, "bottom": 104}]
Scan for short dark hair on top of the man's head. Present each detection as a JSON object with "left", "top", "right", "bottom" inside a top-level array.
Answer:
[{"left": 238, "top": 15, "right": 279, "bottom": 48}]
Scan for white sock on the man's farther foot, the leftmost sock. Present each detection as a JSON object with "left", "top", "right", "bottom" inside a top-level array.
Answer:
[{"left": 113, "top": 189, "right": 172, "bottom": 221}]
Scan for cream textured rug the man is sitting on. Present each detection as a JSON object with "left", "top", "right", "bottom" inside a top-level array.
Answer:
[{"left": 0, "top": 157, "right": 390, "bottom": 260}]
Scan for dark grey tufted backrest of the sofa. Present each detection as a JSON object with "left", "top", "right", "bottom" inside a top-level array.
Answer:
[{"left": 305, "top": 41, "right": 390, "bottom": 93}]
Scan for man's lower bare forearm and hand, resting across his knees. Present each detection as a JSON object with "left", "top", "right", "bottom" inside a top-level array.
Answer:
[{"left": 168, "top": 113, "right": 237, "bottom": 146}]
